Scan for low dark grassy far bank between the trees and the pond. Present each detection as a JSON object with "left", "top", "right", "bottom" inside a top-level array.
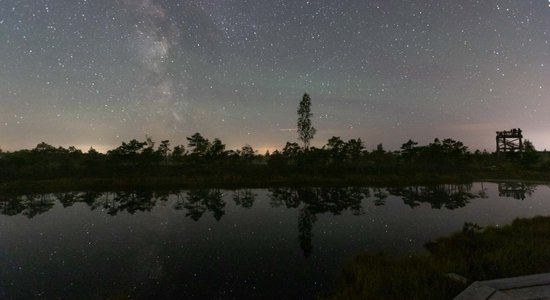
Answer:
[{"left": 0, "top": 170, "right": 550, "bottom": 193}]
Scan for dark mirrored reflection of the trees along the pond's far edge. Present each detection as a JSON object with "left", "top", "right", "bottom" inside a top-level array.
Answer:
[{"left": 0, "top": 182, "right": 520, "bottom": 257}]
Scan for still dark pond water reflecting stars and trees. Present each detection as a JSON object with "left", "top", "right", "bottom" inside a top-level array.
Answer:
[{"left": 0, "top": 182, "right": 550, "bottom": 299}]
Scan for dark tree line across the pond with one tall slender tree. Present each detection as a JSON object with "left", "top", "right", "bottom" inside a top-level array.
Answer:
[{"left": 0, "top": 93, "right": 550, "bottom": 183}]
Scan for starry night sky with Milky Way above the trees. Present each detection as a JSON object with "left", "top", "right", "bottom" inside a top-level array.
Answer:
[{"left": 0, "top": 0, "right": 550, "bottom": 153}]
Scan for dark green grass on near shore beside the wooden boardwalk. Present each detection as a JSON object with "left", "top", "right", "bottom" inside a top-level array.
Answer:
[{"left": 328, "top": 217, "right": 550, "bottom": 299}]
